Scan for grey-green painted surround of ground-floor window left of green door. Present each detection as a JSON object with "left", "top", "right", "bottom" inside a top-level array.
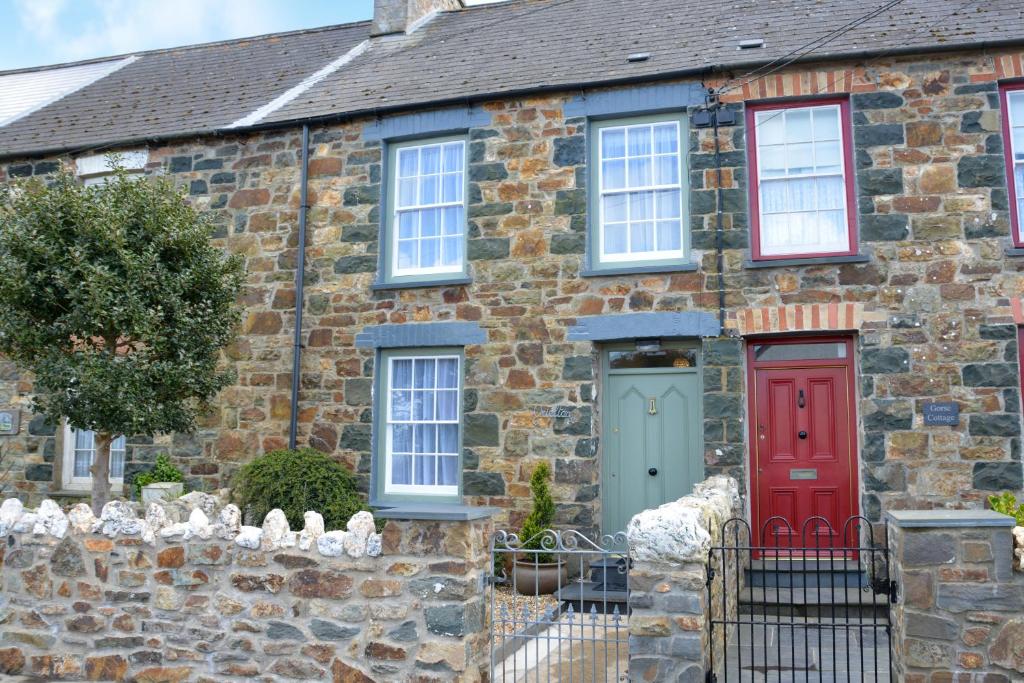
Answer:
[{"left": 370, "top": 346, "right": 466, "bottom": 507}]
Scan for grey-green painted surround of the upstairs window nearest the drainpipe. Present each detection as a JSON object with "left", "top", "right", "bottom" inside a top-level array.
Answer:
[{"left": 371, "top": 131, "right": 470, "bottom": 290}]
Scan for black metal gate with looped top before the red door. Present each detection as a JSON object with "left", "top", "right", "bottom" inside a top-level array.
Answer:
[{"left": 708, "top": 516, "right": 896, "bottom": 683}]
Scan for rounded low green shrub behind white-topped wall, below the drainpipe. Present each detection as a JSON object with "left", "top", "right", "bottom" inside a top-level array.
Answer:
[{"left": 231, "top": 449, "right": 369, "bottom": 529}]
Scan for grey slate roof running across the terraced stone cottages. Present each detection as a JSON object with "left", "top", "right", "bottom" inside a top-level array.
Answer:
[{"left": 0, "top": 0, "right": 1024, "bottom": 158}]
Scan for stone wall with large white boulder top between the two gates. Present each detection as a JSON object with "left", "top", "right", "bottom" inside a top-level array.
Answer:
[{"left": 626, "top": 476, "right": 743, "bottom": 683}]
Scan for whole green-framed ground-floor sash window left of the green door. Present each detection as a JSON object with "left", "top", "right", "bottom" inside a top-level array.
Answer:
[{"left": 373, "top": 347, "right": 466, "bottom": 503}]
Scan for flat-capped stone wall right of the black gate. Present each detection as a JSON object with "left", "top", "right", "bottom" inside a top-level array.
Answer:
[{"left": 889, "top": 511, "right": 1024, "bottom": 683}]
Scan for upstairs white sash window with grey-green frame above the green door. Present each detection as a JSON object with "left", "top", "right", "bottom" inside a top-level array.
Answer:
[{"left": 587, "top": 113, "right": 690, "bottom": 271}]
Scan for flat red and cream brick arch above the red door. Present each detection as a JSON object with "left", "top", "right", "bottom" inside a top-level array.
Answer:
[{"left": 732, "top": 302, "right": 885, "bottom": 337}]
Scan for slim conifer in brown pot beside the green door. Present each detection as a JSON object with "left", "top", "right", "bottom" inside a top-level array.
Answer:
[{"left": 512, "top": 463, "right": 568, "bottom": 595}]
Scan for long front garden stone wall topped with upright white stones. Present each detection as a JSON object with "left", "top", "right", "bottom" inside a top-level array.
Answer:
[{"left": 0, "top": 493, "right": 492, "bottom": 683}]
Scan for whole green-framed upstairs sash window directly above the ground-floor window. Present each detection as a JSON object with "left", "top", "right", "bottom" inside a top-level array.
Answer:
[{"left": 381, "top": 135, "right": 469, "bottom": 286}]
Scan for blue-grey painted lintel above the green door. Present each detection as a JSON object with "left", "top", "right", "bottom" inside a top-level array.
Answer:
[{"left": 567, "top": 310, "right": 722, "bottom": 341}]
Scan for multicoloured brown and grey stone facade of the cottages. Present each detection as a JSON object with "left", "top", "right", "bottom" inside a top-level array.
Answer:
[{"left": 0, "top": 52, "right": 1024, "bottom": 530}]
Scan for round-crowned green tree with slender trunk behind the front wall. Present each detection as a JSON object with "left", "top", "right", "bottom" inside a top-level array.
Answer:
[{"left": 0, "top": 158, "right": 244, "bottom": 513}]
